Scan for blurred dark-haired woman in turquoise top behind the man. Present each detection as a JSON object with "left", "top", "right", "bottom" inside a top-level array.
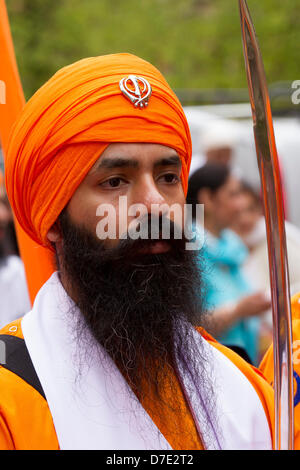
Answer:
[{"left": 187, "top": 163, "right": 270, "bottom": 363}]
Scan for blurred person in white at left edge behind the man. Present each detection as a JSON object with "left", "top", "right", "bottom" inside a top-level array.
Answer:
[{"left": 0, "top": 172, "right": 31, "bottom": 328}]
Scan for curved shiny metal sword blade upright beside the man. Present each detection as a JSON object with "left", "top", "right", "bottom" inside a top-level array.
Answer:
[{"left": 239, "top": 0, "right": 294, "bottom": 450}]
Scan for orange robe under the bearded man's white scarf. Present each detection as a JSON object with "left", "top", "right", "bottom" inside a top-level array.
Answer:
[{"left": 0, "top": 319, "right": 274, "bottom": 450}]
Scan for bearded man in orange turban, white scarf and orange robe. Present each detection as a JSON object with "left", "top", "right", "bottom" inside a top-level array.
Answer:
[{"left": 0, "top": 54, "right": 273, "bottom": 450}]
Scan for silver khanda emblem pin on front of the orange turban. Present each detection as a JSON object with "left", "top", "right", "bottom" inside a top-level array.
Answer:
[{"left": 119, "top": 75, "right": 152, "bottom": 108}]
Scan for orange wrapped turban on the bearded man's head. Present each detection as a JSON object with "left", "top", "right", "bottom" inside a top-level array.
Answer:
[{"left": 5, "top": 54, "right": 192, "bottom": 245}]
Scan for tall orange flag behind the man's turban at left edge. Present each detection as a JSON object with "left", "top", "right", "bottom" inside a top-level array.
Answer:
[{"left": 0, "top": 0, "right": 54, "bottom": 302}]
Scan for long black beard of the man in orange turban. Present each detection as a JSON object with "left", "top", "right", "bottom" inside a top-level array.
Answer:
[{"left": 55, "top": 210, "right": 211, "bottom": 436}]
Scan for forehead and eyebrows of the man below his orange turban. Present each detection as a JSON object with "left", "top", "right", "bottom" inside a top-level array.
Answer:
[{"left": 90, "top": 143, "right": 181, "bottom": 173}]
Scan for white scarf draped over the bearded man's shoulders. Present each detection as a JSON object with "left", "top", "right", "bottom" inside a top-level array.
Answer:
[{"left": 22, "top": 273, "right": 271, "bottom": 450}]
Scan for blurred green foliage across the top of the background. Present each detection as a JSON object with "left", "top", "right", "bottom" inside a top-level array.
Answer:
[{"left": 7, "top": 0, "right": 300, "bottom": 97}]
